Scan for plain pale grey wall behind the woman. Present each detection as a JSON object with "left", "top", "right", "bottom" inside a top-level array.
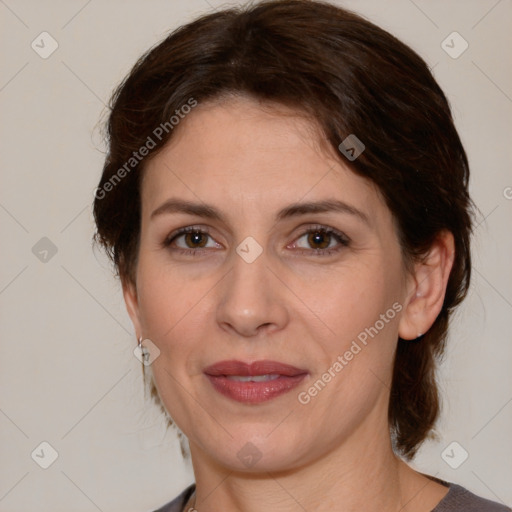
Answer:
[{"left": 0, "top": 0, "right": 512, "bottom": 512}]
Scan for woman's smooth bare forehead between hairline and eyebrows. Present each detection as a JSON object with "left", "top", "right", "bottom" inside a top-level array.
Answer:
[{"left": 142, "top": 98, "right": 387, "bottom": 226}]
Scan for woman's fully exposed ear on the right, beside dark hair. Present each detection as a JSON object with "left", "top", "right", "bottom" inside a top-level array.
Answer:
[{"left": 398, "top": 231, "right": 455, "bottom": 340}]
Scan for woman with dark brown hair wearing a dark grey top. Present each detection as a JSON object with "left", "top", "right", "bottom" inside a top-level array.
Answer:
[{"left": 94, "top": 0, "right": 506, "bottom": 512}]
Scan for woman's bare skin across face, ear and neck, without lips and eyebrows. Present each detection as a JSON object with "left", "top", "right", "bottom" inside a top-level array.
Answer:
[{"left": 123, "top": 97, "right": 454, "bottom": 512}]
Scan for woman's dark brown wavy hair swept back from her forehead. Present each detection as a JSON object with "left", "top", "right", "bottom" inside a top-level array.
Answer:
[{"left": 94, "top": 0, "right": 472, "bottom": 458}]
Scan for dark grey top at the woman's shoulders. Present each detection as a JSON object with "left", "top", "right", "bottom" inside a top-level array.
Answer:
[{"left": 154, "top": 478, "right": 512, "bottom": 512}]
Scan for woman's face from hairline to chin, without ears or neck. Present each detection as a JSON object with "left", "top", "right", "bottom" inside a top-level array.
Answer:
[{"left": 125, "top": 98, "right": 418, "bottom": 471}]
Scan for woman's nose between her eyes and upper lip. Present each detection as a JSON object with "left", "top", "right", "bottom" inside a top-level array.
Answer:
[{"left": 217, "top": 252, "right": 289, "bottom": 337}]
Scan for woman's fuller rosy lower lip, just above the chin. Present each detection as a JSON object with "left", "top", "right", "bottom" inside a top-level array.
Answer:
[{"left": 206, "top": 373, "right": 307, "bottom": 404}]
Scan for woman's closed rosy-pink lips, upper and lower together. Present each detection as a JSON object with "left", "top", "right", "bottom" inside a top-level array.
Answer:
[{"left": 204, "top": 360, "right": 309, "bottom": 404}]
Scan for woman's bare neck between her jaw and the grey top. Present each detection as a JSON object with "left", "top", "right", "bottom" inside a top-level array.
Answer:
[{"left": 185, "top": 418, "right": 447, "bottom": 512}]
